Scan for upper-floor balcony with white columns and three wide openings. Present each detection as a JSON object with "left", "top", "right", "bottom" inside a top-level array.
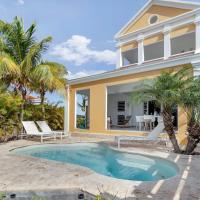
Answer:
[{"left": 117, "top": 9, "right": 200, "bottom": 68}]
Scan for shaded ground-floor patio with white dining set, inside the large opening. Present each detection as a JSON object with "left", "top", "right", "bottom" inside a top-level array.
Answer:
[{"left": 107, "top": 80, "right": 178, "bottom": 133}]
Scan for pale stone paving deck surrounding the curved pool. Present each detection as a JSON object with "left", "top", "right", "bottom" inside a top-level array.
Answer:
[{"left": 0, "top": 137, "right": 200, "bottom": 200}]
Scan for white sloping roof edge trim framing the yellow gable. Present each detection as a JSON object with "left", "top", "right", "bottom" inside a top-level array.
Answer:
[{"left": 115, "top": 0, "right": 200, "bottom": 39}]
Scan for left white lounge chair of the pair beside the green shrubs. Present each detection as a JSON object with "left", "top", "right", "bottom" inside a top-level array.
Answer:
[{"left": 22, "top": 121, "right": 56, "bottom": 142}]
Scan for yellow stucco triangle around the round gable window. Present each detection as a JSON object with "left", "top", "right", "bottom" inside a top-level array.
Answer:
[{"left": 121, "top": 5, "right": 191, "bottom": 36}]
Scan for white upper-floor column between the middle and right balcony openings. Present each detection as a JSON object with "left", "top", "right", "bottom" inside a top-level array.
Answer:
[{"left": 163, "top": 27, "right": 171, "bottom": 59}]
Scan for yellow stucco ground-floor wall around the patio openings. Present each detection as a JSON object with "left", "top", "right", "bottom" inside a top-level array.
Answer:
[{"left": 69, "top": 67, "right": 189, "bottom": 142}]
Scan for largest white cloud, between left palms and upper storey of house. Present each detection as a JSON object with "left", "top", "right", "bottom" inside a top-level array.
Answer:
[{"left": 50, "top": 35, "right": 116, "bottom": 65}]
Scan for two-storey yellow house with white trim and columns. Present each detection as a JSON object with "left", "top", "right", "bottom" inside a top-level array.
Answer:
[{"left": 65, "top": 0, "right": 200, "bottom": 145}]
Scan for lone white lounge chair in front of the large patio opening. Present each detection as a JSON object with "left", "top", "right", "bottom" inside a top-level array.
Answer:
[{"left": 115, "top": 122, "right": 165, "bottom": 148}]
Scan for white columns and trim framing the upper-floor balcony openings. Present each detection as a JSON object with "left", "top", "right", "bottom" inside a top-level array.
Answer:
[{"left": 117, "top": 9, "right": 200, "bottom": 68}]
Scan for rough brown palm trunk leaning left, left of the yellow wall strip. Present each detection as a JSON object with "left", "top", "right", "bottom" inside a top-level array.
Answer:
[{"left": 163, "top": 106, "right": 181, "bottom": 153}]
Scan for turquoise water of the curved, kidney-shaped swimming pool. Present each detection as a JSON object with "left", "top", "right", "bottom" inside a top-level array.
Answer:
[{"left": 14, "top": 143, "right": 178, "bottom": 181}]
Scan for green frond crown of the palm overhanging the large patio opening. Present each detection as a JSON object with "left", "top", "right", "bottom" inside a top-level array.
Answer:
[{"left": 132, "top": 67, "right": 191, "bottom": 107}]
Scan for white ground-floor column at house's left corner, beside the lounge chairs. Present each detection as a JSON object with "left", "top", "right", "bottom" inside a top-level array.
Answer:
[{"left": 64, "top": 83, "right": 69, "bottom": 135}]
